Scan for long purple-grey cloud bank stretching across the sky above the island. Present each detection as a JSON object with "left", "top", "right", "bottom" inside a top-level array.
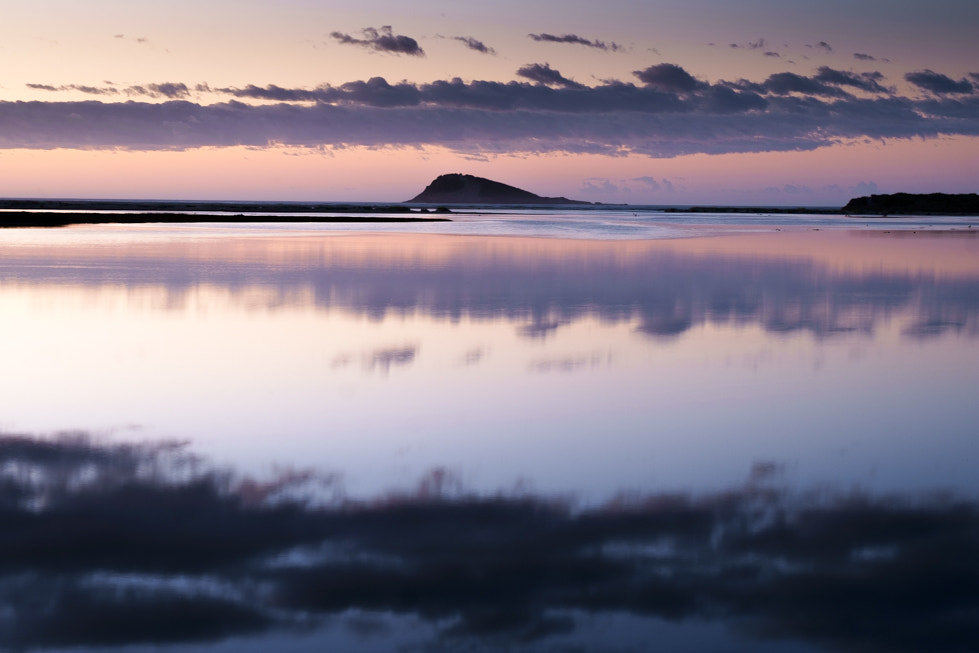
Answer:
[{"left": 7, "top": 63, "right": 979, "bottom": 157}]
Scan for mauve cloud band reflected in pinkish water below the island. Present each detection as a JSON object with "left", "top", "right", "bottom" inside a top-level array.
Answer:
[{"left": 0, "top": 234, "right": 979, "bottom": 338}]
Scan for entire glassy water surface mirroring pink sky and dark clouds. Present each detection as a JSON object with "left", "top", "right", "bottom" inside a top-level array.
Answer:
[{"left": 0, "top": 225, "right": 979, "bottom": 651}]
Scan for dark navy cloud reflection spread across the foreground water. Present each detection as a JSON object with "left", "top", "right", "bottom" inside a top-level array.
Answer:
[{"left": 0, "top": 434, "right": 979, "bottom": 652}]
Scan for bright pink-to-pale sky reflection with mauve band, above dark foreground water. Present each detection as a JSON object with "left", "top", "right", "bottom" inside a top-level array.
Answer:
[{"left": 0, "top": 227, "right": 979, "bottom": 500}]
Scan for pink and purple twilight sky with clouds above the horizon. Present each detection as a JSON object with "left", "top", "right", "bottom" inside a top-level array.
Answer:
[{"left": 0, "top": 0, "right": 979, "bottom": 206}]
